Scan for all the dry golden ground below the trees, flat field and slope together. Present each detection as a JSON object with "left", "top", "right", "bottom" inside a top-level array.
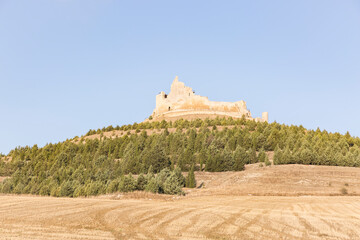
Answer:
[{"left": 0, "top": 165, "right": 360, "bottom": 240}]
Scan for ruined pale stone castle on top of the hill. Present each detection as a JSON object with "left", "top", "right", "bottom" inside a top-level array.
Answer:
[{"left": 151, "top": 77, "right": 268, "bottom": 122}]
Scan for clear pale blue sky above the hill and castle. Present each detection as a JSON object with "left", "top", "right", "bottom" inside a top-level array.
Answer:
[{"left": 0, "top": 0, "right": 360, "bottom": 153}]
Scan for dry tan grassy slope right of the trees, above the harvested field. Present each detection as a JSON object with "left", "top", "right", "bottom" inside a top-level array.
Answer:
[{"left": 191, "top": 164, "right": 360, "bottom": 196}]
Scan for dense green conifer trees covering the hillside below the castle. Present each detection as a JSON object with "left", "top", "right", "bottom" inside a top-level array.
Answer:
[{"left": 0, "top": 118, "right": 360, "bottom": 197}]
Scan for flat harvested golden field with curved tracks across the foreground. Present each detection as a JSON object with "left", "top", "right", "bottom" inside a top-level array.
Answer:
[{"left": 0, "top": 196, "right": 360, "bottom": 239}]
